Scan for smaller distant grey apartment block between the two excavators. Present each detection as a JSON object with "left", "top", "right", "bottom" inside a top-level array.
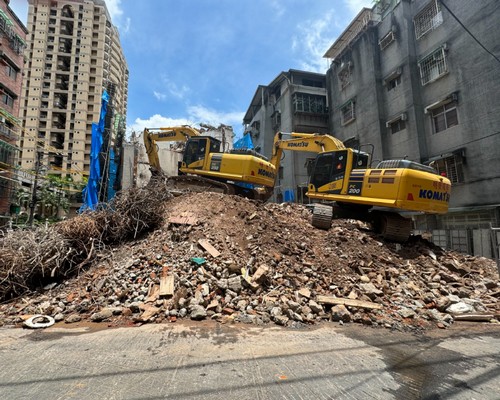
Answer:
[{"left": 243, "top": 69, "right": 328, "bottom": 202}]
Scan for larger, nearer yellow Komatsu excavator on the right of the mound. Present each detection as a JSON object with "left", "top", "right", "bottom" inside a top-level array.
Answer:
[{"left": 271, "top": 132, "right": 451, "bottom": 241}]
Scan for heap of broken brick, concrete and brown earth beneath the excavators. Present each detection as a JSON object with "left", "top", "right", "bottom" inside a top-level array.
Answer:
[{"left": 0, "top": 193, "right": 500, "bottom": 330}]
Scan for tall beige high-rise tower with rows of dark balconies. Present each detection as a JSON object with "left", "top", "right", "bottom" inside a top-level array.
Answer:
[{"left": 18, "top": 0, "right": 129, "bottom": 209}]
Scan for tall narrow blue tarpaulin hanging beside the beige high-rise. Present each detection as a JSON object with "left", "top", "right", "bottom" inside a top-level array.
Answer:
[{"left": 80, "top": 90, "right": 109, "bottom": 212}]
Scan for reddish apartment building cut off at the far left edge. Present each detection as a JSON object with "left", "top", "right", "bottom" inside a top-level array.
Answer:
[{"left": 0, "top": 0, "right": 28, "bottom": 226}]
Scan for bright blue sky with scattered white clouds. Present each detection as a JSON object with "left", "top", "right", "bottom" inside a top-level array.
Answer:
[{"left": 10, "top": 0, "right": 373, "bottom": 136}]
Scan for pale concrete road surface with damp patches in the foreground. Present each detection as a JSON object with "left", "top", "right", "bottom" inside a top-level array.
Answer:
[{"left": 0, "top": 321, "right": 500, "bottom": 400}]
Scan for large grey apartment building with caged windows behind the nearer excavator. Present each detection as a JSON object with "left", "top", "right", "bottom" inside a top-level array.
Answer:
[{"left": 325, "top": 0, "right": 500, "bottom": 256}]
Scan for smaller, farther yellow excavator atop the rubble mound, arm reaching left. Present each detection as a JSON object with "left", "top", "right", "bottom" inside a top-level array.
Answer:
[{"left": 143, "top": 126, "right": 276, "bottom": 201}]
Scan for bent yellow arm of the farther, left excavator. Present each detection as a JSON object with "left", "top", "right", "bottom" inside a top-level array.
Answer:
[{"left": 143, "top": 125, "right": 200, "bottom": 172}]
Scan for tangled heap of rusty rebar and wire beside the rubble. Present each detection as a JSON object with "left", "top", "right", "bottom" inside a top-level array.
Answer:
[{"left": 0, "top": 177, "right": 172, "bottom": 300}]
